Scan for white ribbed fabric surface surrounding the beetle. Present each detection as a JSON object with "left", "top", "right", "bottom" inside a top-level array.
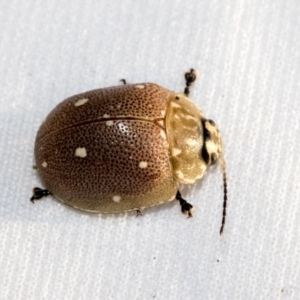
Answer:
[{"left": 0, "top": 0, "right": 300, "bottom": 300}]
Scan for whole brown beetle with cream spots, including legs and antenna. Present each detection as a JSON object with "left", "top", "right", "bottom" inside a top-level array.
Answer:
[{"left": 30, "top": 69, "right": 227, "bottom": 234}]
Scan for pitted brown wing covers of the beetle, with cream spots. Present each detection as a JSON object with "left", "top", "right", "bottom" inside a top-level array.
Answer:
[{"left": 35, "top": 84, "right": 178, "bottom": 213}]
